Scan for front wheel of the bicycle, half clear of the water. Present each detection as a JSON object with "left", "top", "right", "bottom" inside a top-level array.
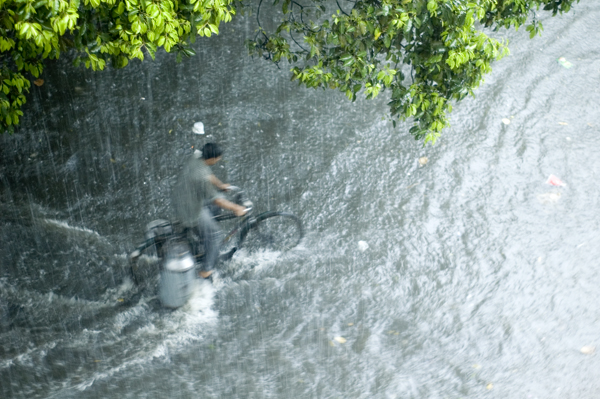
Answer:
[{"left": 240, "top": 211, "right": 304, "bottom": 252}]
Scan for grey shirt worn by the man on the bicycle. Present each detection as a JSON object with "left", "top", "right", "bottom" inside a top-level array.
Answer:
[{"left": 173, "top": 154, "right": 221, "bottom": 227}]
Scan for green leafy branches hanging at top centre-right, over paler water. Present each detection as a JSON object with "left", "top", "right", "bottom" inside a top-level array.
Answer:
[{"left": 248, "top": 0, "right": 579, "bottom": 143}]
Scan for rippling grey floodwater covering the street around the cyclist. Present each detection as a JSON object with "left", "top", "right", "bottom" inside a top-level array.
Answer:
[{"left": 0, "top": 2, "right": 600, "bottom": 399}]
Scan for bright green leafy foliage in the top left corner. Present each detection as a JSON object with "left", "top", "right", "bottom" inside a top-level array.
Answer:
[{"left": 0, "top": 0, "right": 235, "bottom": 132}]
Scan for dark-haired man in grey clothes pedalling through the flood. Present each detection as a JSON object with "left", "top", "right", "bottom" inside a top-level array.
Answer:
[{"left": 173, "top": 143, "right": 246, "bottom": 278}]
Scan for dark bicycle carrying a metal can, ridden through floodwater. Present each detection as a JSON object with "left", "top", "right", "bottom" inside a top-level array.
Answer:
[{"left": 129, "top": 186, "right": 304, "bottom": 282}]
